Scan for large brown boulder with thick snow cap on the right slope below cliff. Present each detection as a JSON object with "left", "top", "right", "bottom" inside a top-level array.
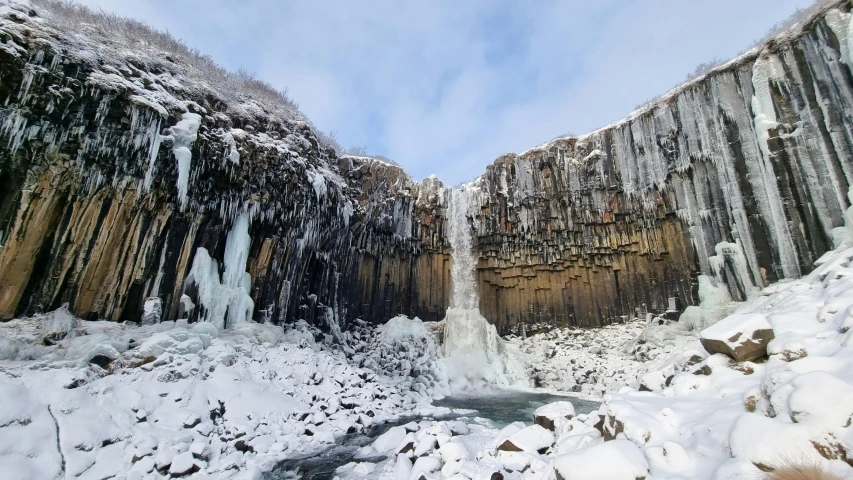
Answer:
[{"left": 699, "top": 313, "right": 775, "bottom": 362}]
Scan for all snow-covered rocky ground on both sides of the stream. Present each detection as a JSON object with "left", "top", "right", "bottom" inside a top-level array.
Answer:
[{"left": 5, "top": 249, "right": 853, "bottom": 480}]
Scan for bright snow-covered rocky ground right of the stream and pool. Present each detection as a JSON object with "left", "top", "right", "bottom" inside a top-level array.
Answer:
[{"left": 339, "top": 249, "right": 853, "bottom": 480}]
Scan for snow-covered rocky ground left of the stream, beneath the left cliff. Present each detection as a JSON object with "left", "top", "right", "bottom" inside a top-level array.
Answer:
[{"left": 0, "top": 310, "right": 442, "bottom": 479}]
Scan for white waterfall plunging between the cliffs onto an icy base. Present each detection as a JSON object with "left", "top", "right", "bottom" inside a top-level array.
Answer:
[{"left": 443, "top": 185, "right": 529, "bottom": 389}]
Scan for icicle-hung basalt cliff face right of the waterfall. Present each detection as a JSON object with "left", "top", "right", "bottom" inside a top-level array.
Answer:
[{"left": 456, "top": 1, "right": 853, "bottom": 325}]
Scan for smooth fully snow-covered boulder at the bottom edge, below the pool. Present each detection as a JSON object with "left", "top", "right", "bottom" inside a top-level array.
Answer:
[{"left": 554, "top": 440, "right": 649, "bottom": 480}]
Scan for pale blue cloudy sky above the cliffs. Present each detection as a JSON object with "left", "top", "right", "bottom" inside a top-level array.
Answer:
[{"left": 79, "top": 0, "right": 813, "bottom": 185}]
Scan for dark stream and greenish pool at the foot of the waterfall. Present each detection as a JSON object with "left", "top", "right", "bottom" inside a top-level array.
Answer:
[{"left": 264, "top": 390, "right": 599, "bottom": 480}]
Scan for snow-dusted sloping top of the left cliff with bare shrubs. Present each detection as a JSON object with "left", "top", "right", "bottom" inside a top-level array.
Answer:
[{"left": 0, "top": 0, "right": 316, "bottom": 137}]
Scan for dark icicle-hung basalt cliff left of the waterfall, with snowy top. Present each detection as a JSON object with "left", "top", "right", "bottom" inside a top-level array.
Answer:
[{"left": 0, "top": 0, "right": 444, "bottom": 330}]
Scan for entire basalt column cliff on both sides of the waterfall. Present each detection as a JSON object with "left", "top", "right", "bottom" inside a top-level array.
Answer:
[{"left": 0, "top": 0, "right": 853, "bottom": 333}]
